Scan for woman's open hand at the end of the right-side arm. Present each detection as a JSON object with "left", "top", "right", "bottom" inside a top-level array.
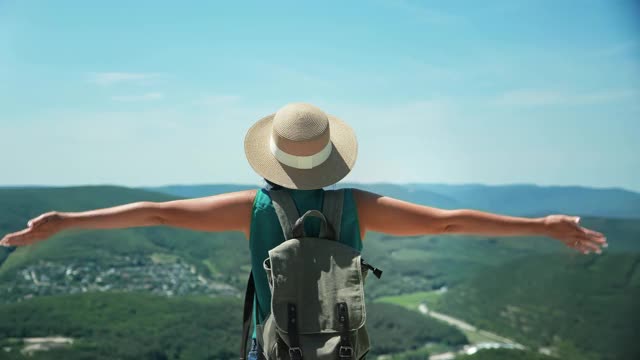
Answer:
[{"left": 544, "top": 215, "right": 608, "bottom": 254}]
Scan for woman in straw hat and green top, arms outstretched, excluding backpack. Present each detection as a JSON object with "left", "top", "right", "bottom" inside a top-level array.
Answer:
[{"left": 0, "top": 104, "right": 606, "bottom": 358}]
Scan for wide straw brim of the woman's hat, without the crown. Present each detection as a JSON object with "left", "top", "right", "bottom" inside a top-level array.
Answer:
[{"left": 244, "top": 114, "right": 358, "bottom": 190}]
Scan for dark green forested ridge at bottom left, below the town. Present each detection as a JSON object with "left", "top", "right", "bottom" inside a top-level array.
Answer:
[{"left": 0, "top": 293, "right": 242, "bottom": 359}]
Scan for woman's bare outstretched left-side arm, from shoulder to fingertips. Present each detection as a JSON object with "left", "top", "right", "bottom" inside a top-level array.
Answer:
[{"left": 0, "top": 190, "right": 256, "bottom": 246}]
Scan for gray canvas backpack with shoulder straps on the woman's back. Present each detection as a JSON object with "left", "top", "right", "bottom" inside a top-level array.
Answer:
[{"left": 240, "top": 190, "right": 382, "bottom": 360}]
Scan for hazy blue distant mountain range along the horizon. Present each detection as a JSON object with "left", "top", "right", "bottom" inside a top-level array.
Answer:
[{"left": 144, "top": 183, "right": 640, "bottom": 218}]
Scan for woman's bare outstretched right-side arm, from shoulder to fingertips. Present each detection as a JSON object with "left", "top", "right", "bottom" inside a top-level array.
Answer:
[{"left": 354, "top": 190, "right": 606, "bottom": 252}]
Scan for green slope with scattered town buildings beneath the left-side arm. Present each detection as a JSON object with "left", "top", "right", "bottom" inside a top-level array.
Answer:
[{"left": 0, "top": 227, "right": 249, "bottom": 302}]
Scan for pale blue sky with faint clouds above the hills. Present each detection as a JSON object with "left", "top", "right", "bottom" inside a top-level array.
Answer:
[{"left": 0, "top": 0, "right": 640, "bottom": 191}]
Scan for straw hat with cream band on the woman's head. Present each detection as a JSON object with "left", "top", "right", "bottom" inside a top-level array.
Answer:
[{"left": 244, "top": 103, "right": 358, "bottom": 190}]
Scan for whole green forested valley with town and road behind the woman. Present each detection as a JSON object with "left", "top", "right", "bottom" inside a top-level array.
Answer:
[{"left": 0, "top": 187, "right": 640, "bottom": 360}]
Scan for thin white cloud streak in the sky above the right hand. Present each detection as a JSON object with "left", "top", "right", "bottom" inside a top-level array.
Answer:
[{"left": 492, "top": 89, "right": 640, "bottom": 106}]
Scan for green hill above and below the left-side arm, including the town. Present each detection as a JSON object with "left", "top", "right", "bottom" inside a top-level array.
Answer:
[{"left": 0, "top": 186, "right": 249, "bottom": 302}]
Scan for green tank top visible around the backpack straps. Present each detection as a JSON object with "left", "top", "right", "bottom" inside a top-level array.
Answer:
[{"left": 249, "top": 189, "right": 362, "bottom": 338}]
